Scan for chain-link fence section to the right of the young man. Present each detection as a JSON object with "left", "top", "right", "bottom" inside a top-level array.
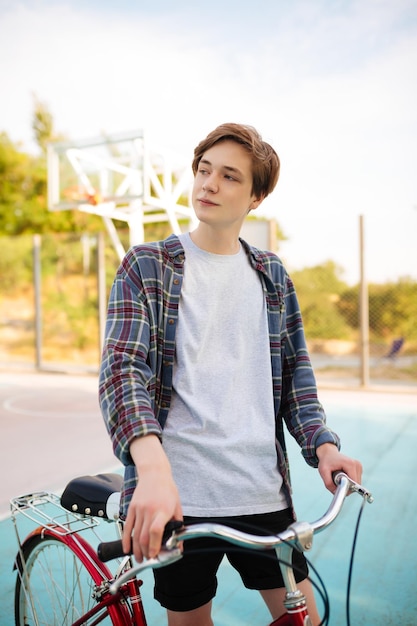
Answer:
[{"left": 292, "top": 262, "right": 417, "bottom": 386}]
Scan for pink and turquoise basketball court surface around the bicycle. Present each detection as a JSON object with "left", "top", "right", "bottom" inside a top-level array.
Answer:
[{"left": 0, "top": 371, "right": 417, "bottom": 626}]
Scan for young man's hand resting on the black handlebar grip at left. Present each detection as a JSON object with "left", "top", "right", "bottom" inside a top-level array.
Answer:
[{"left": 123, "top": 435, "right": 182, "bottom": 562}]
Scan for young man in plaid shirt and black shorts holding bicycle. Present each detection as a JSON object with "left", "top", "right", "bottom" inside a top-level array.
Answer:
[{"left": 100, "top": 124, "right": 362, "bottom": 626}]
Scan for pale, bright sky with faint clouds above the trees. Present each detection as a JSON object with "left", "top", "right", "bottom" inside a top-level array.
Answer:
[{"left": 0, "top": 0, "right": 417, "bottom": 283}]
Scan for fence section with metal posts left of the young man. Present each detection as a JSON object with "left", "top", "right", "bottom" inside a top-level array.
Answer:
[{"left": 0, "top": 234, "right": 119, "bottom": 370}]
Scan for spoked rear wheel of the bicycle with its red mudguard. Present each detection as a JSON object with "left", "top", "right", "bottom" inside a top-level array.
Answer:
[{"left": 15, "top": 531, "right": 132, "bottom": 626}]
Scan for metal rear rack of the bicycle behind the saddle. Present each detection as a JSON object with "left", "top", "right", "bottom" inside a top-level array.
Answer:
[{"left": 10, "top": 491, "right": 100, "bottom": 537}]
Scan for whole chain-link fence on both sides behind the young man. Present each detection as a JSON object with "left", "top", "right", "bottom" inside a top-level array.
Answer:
[{"left": 0, "top": 229, "right": 417, "bottom": 386}]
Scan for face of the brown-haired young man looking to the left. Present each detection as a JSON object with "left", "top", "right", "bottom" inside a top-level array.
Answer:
[{"left": 192, "top": 140, "right": 260, "bottom": 229}]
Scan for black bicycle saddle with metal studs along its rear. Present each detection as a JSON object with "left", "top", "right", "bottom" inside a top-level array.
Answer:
[{"left": 61, "top": 474, "right": 123, "bottom": 520}]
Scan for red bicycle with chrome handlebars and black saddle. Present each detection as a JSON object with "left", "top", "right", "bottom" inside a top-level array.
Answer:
[{"left": 11, "top": 472, "right": 372, "bottom": 626}]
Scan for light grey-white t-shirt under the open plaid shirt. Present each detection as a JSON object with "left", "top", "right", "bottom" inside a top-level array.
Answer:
[{"left": 163, "top": 234, "right": 287, "bottom": 517}]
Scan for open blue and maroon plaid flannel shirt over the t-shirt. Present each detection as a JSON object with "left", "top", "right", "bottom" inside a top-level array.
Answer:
[{"left": 99, "top": 235, "right": 340, "bottom": 514}]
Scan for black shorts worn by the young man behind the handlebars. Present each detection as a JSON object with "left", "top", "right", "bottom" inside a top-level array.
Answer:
[{"left": 153, "top": 509, "right": 308, "bottom": 611}]
